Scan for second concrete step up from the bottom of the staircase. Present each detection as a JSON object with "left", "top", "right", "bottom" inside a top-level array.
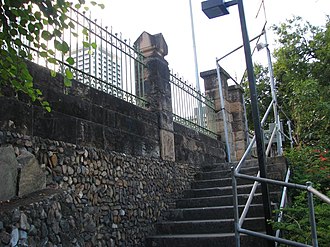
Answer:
[{"left": 156, "top": 217, "right": 265, "bottom": 234}]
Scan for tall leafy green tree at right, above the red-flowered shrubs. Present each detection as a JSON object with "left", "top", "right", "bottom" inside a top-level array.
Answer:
[{"left": 273, "top": 17, "right": 330, "bottom": 145}]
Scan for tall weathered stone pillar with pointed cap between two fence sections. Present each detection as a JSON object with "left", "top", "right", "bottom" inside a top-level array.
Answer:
[{"left": 135, "top": 32, "right": 175, "bottom": 161}]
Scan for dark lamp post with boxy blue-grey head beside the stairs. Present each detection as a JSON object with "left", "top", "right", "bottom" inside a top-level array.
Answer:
[{"left": 202, "top": 0, "right": 274, "bottom": 246}]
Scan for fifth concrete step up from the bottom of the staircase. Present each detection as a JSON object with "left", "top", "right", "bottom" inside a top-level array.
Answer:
[{"left": 183, "top": 184, "right": 260, "bottom": 198}]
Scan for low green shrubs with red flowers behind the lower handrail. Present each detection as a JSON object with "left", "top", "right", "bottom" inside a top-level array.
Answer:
[{"left": 273, "top": 146, "right": 330, "bottom": 247}]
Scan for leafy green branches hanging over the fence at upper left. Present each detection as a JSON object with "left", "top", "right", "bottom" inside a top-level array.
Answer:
[{"left": 0, "top": 0, "right": 104, "bottom": 111}]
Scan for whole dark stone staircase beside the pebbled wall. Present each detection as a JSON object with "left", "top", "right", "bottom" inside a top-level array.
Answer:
[{"left": 146, "top": 161, "right": 284, "bottom": 247}]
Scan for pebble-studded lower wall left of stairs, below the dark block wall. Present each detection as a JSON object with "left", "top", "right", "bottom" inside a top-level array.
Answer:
[{"left": 0, "top": 131, "right": 198, "bottom": 247}]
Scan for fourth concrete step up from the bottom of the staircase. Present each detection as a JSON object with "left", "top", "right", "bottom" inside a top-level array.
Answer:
[{"left": 176, "top": 193, "right": 262, "bottom": 208}]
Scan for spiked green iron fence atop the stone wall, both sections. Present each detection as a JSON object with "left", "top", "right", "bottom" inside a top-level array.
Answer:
[{"left": 16, "top": 5, "right": 217, "bottom": 138}]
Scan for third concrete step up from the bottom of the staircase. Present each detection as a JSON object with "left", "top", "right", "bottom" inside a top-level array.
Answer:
[{"left": 164, "top": 204, "right": 263, "bottom": 221}]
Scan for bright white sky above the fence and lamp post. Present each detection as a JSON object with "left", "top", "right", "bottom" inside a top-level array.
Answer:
[{"left": 92, "top": 0, "right": 330, "bottom": 87}]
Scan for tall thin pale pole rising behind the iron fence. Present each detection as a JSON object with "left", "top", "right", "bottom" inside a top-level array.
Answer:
[{"left": 189, "top": 0, "right": 204, "bottom": 127}]
